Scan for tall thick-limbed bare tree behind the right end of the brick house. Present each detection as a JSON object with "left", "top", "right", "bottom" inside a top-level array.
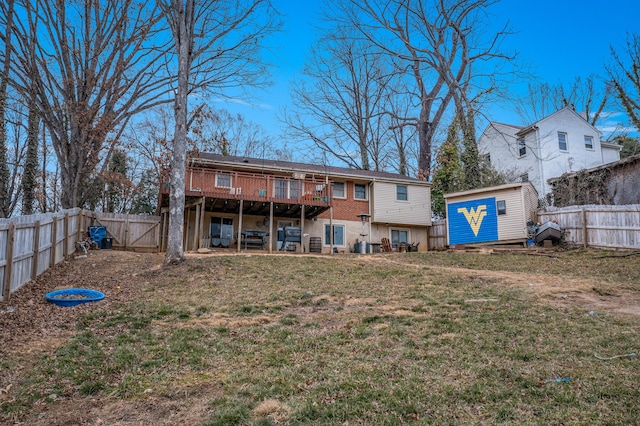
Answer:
[{"left": 345, "top": 0, "right": 512, "bottom": 179}]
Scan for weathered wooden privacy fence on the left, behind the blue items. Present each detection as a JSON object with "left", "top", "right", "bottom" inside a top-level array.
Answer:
[{"left": 0, "top": 208, "right": 160, "bottom": 300}]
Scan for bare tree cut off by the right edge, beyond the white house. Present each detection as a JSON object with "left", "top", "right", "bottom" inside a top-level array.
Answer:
[{"left": 606, "top": 34, "right": 640, "bottom": 130}]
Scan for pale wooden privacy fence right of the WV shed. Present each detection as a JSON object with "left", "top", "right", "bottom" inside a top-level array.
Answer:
[{"left": 538, "top": 204, "right": 640, "bottom": 249}]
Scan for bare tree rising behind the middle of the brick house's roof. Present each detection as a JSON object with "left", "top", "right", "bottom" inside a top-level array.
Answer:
[{"left": 284, "top": 24, "right": 393, "bottom": 170}]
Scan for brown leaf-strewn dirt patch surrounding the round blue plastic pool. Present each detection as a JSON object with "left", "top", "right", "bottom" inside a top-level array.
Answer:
[{"left": 0, "top": 250, "right": 164, "bottom": 354}]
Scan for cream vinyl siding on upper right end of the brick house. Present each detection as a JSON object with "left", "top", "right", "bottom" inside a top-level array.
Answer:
[{"left": 371, "top": 182, "right": 431, "bottom": 226}]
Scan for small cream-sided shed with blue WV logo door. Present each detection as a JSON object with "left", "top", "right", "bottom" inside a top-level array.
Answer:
[{"left": 444, "top": 182, "right": 538, "bottom": 246}]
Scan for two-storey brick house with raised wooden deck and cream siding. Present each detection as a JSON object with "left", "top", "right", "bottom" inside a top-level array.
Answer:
[{"left": 159, "top": 154, "right": 431, "bottom": 253}]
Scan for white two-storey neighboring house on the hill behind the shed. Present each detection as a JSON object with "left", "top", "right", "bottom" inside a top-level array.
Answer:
[{"left": 478, "top": 107, "right": 621, "bottom": 197}]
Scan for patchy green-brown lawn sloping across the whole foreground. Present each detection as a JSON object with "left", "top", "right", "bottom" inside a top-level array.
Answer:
[{"left": 0, "top": 250, "right": 640, "bottom": 425}]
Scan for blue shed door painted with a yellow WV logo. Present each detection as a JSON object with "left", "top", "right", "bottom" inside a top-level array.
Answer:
[{"left": 447, "top": 197, "right": 498, "bottom": 245}]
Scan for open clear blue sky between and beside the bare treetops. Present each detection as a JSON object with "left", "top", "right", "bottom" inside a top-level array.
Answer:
[{"left": 216, "top": 0, "right": 640, "bottom": 142}]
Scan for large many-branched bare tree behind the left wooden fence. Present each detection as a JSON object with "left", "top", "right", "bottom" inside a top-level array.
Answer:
[{"left": 10, "top": 0, "right": 171, "bottom": 208}]
